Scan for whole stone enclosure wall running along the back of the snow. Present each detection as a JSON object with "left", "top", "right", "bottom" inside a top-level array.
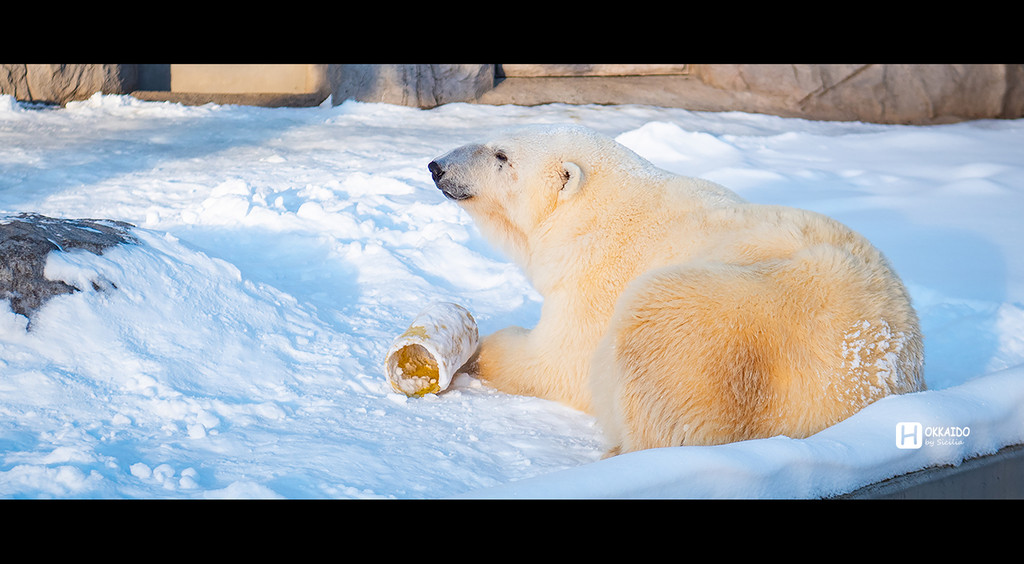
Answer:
[{"left": 0, "top": 64, "right": 1024, "bottom": 124}]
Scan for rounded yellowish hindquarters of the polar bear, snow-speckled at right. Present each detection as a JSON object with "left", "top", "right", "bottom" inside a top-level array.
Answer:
[{"left": 594, "top": 202, "right": 924, "bottom": 450}]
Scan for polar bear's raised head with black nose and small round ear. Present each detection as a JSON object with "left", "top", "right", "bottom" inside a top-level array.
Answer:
[{"left": 428, "top": 126, "right": 636, "bottom": 262}]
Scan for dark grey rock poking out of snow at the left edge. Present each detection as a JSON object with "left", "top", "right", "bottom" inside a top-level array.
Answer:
[{"left": 0, "top": 214, "right": 137, "bottom": 318}]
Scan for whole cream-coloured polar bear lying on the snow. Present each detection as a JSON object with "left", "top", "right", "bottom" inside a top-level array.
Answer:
[{"left": 428, "top": 126, "right": 925, "bottom": 455}]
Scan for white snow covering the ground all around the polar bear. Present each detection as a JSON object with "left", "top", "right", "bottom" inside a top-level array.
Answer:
[{"left": 0, "top": 94, "right": 1024, "bottom": 498}]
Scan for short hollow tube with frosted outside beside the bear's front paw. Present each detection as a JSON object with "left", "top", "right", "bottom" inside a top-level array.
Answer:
[{"left": 384, "top": 302, "right": 479, "bottom": 397}]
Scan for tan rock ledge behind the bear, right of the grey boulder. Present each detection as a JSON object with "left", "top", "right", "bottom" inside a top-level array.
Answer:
[{"left": 478, "top": 63, "right": 1024, "bottom": 125}]
